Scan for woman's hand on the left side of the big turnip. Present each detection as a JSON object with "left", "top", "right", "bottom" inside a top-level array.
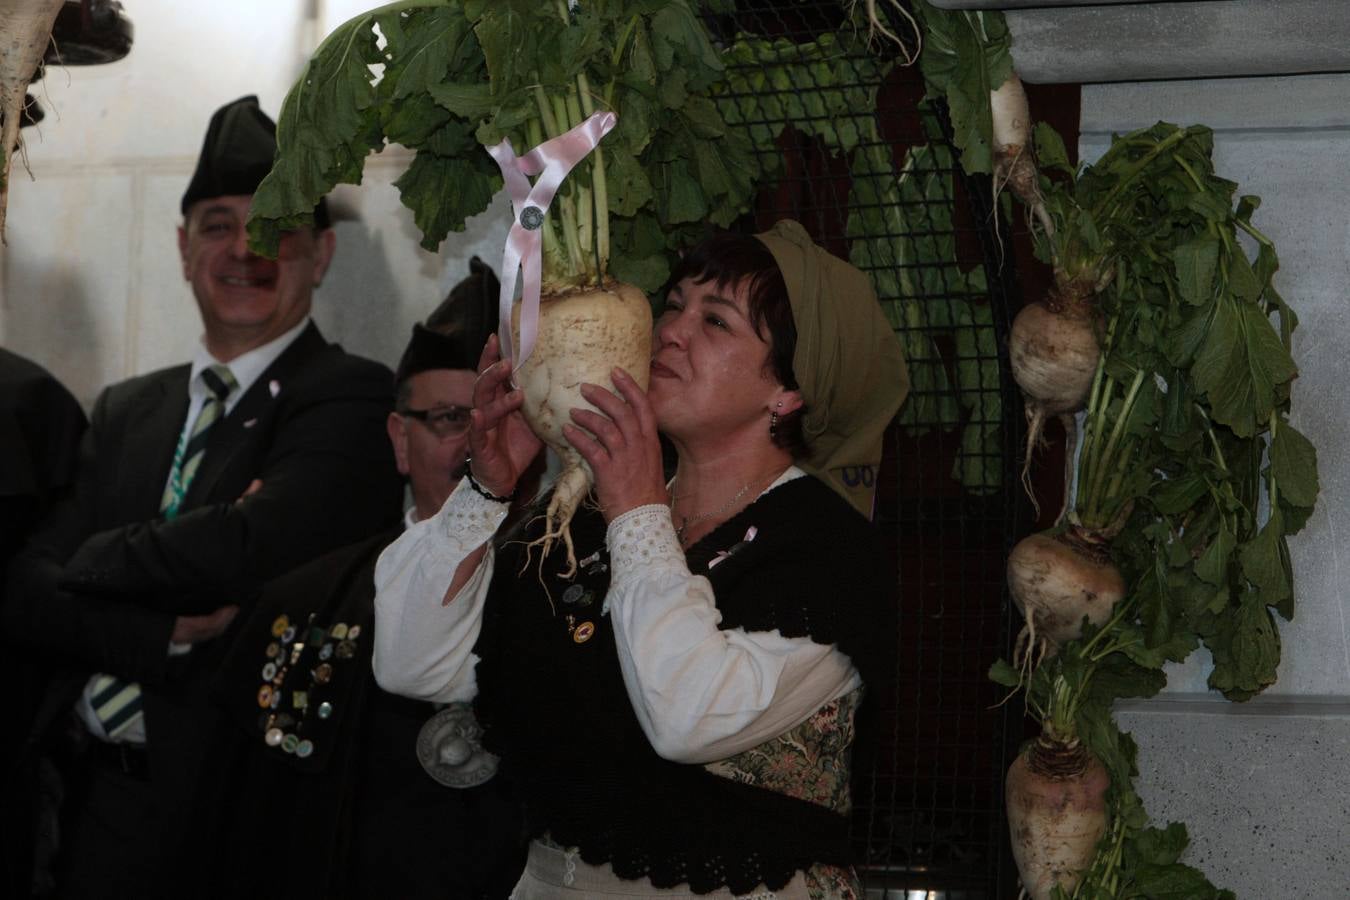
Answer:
[{"left": 468, "top": 335, "right": 544, "bottom": 497}]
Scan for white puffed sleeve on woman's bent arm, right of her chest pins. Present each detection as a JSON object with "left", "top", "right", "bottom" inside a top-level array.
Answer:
[{"left": 606, "top": 505, "right": 863, "bottom": 762}]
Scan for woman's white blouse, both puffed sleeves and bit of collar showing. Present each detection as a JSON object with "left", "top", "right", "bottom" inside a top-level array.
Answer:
[{"left": 374, "top": 467, "right": 863, "bottom": 762}]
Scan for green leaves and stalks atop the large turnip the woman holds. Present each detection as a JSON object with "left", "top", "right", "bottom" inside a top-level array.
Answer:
[{"left": 250, "top": 0, "right": 760, "bottom": 291}]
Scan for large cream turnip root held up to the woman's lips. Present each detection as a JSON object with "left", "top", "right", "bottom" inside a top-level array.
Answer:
[{"left": 512, "top": 281, "right": 652, "bottom": 578}]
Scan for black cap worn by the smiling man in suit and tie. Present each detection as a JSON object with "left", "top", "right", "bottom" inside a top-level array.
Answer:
[{"left": 180, "top": 94, "right": 328, "bottom": 228}]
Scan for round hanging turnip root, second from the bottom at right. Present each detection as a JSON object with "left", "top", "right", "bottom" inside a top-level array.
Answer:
[{"left": 1007, "top": 526, "right": 1125, "bottom": 669}]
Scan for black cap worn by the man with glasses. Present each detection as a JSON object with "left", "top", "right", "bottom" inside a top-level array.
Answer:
[{"left": 394, "top": 256, "right": 501, "bottom": 385}]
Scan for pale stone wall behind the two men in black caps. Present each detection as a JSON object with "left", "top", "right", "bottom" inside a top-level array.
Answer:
[{"left": 0, "top": 0, "right": 509, "bottom": 405}]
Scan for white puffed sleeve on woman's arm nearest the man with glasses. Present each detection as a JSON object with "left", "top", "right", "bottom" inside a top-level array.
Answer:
[{"left": 374, "top": 479, "right": 509, "bottom": 703}]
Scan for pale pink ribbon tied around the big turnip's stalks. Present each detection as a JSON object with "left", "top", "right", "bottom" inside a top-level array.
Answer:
[{"left": 487, "top": 112, "right": 618, "bottom": 371}]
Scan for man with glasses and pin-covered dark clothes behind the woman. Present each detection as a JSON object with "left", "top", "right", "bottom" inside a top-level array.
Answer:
[{"left": 216, "top": 258, "right": 524, "bottom": 900}]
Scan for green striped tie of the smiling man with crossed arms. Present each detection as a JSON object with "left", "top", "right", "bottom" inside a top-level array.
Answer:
[{"left": 89, "top": 364, "right": 239, "bottom": 738}]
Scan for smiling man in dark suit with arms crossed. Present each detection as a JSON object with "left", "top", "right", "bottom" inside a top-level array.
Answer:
[{"left": 3, "top": 97, "right": 401, "bottom": 897}]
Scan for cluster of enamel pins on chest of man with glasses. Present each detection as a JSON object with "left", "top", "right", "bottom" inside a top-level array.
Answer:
[{"left": 258, "top": 613, "right": 360, "bottom": 758}]
